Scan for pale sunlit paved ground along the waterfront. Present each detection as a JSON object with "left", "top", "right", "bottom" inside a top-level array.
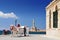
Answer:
[{"left": 0, "top": 34, "right": 60, "bottom": 40}]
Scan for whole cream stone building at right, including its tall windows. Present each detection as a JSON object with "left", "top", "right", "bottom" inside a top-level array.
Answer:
[{"left": 46, "top": 0, "right": 60, "bottom": 37}]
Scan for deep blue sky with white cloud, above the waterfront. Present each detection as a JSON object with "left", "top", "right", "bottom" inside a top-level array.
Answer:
[{"left": 0, "top": 0, "right": 52, "bottom": 30}]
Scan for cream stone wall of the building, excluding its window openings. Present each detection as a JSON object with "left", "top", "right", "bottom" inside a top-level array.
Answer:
[{"left": 46, "top": 0, "right": 60, "bottom": 37}]
